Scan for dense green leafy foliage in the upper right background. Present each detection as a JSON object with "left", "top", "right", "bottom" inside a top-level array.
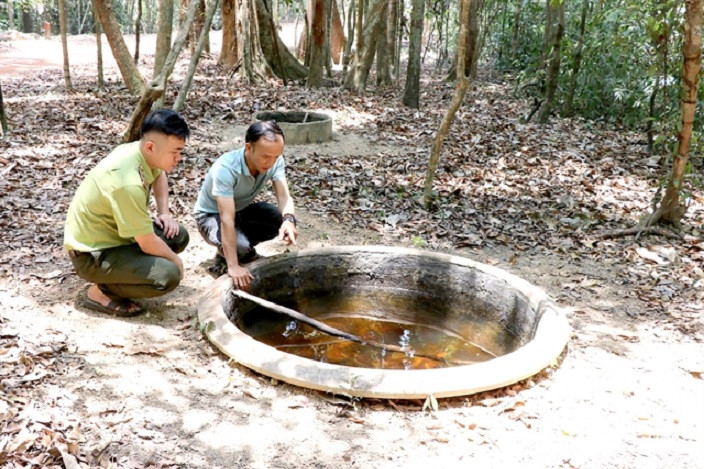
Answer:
[{"left": 486, "top": 0, "right": 704, "bottom": 152}]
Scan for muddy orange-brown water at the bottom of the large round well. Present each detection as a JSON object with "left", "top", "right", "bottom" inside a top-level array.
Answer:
[{"left": 239, "top": 292, "right": 520, "bottom": 370}]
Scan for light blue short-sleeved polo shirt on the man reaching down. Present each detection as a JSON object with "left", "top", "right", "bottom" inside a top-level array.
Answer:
[{"left": 193, "top": 147, "right": 286, "bottom": 217}]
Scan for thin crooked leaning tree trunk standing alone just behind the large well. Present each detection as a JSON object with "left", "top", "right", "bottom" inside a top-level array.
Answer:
[{"left": 420, "top": 0, "right": 471, "bottom": 209}]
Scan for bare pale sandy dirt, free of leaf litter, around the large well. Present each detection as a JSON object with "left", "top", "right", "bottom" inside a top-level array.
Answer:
[{"left": 0, "top": 31, "right": 704, "bottom": 469}]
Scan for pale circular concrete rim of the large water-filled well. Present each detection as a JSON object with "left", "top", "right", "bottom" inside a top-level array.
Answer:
[{"left": 198, "top": 246, "right": 569, "bottom": 399}]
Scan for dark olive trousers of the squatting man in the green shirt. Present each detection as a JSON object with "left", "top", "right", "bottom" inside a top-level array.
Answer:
[{"left": 69, "top": 224, "right": 189, "bottom": 300}]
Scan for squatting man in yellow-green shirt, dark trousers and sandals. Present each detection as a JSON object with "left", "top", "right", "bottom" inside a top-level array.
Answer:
[{"left": 64, "top": 109, "right": 190, "bottom": 316}]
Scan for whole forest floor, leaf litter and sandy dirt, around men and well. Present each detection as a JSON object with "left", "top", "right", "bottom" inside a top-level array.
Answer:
[{"left": 0, "top": 31, "right": 704, "bottom": 469}]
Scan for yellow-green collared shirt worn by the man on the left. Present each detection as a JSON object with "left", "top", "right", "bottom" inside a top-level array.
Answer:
[{"left": 64, "top": 141, "right": 161, "bottom": 252}]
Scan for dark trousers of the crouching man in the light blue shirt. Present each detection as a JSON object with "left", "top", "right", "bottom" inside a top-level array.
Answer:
[{"left": 197, "top": 202, "right": 283, "bottom": 258}]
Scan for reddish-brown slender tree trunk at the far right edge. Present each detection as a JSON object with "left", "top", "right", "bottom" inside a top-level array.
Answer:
[{"left": 649, "top": 0, "right": 703, "bottom": 229}]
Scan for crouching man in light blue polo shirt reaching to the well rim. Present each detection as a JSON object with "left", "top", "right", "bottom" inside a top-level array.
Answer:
[{"left": 194, "top": 121, "right": 298, "bottom": 290}]
